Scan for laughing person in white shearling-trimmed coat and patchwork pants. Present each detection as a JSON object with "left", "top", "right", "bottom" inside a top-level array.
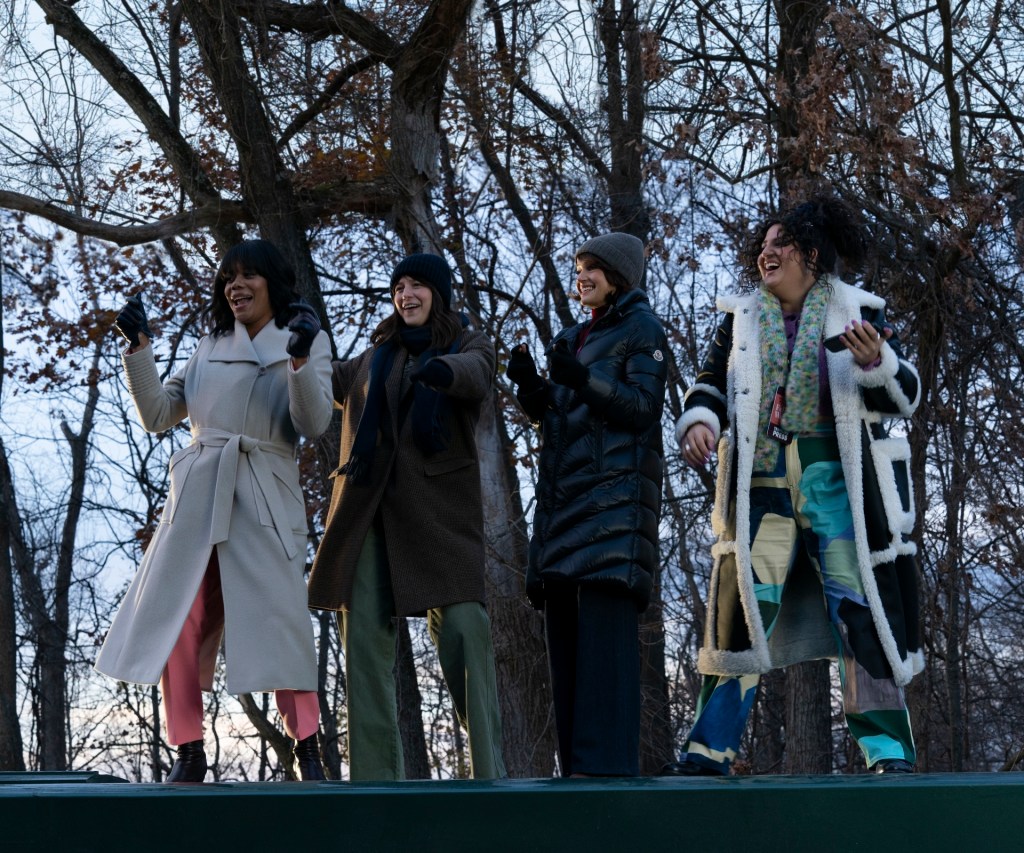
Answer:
[{"left": 663, "top": 199, "right": 923, "bottom": 775}]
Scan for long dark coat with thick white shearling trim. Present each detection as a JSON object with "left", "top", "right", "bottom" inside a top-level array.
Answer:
[{"left": 676, "top": 276, "right": 924, "bottom": 685}]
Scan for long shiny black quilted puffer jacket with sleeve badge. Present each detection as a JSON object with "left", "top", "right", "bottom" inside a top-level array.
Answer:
[{"left": 519, "top": 291, "right": 668, "bottom": 609}]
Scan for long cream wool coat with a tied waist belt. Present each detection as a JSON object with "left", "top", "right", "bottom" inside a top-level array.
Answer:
[{"left": 96, "top": 323, "right": 334, "bottom": 693}]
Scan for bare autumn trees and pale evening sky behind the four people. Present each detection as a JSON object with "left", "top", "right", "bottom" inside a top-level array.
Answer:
[{"left": 0, "top": 0, "right": 1024, "bottom": 780}]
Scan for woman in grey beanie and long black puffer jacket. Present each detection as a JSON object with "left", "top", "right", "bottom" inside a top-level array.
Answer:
[{"left": 507, "top": 233, "right": 667, "bottom": 776}]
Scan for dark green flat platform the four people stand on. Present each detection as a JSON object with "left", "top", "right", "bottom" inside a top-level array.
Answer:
[{"left": 0, "top": 773, "right": 1024, "bottom": 853}]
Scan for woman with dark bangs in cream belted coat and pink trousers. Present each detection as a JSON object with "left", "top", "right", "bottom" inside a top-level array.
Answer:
[{"left": 96, "top": 241, "right": 333, "bottom": 781}]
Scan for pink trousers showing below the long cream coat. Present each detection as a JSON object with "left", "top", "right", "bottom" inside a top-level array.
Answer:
[{"left": 160, "top": 551, "right": 319, "bottom": 747}]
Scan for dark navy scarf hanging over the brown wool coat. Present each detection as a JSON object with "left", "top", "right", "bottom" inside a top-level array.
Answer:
[{"left": 338, "top": 324, "right": 459, "bottom": 484}]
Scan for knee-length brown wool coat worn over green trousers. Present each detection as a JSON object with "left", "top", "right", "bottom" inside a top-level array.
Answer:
[{"left": 309, "top": 331, "right": 496, "bottom": 615}]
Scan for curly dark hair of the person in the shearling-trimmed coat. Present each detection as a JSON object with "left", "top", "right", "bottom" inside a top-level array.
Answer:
[{"left": 739, "top": 196, "right": 867, "bottom": 287}]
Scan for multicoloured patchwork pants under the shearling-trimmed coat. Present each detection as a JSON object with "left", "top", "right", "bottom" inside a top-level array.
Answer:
[{"left": 683, "top": 435, "right": 915, "bottom": 773}]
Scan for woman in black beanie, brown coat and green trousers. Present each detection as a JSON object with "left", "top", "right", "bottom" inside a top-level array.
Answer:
[{"left": 309, "top": 254, "right": 506, "bottom": 780}]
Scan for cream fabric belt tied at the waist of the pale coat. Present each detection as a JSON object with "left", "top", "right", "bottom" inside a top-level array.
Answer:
[{"left": 193, "top": 427, "right": 298, "bottom": 560}]
